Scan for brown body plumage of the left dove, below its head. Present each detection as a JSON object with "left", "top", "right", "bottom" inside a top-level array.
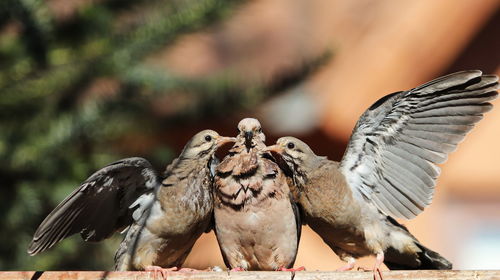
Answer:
[{"left": 115, "top": 150, "right": 213, "bottom": 270}]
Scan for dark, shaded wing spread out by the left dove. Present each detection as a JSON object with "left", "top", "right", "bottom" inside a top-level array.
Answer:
[{"left": 28, "top": 157, "right": 159, "bottom": 255}]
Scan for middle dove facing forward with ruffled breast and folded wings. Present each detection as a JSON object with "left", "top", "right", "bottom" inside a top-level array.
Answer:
[{"left": 214, "top": 118, "right": 302, "bottom": 271}]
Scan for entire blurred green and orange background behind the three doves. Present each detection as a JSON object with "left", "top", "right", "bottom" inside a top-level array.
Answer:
[{"left": 0, "top": 0, "right": 500, "bottom": 270}]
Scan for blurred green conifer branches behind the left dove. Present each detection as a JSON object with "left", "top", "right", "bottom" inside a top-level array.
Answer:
[{"left": 0, "top": 0, "right": 327, "bottom": 270}]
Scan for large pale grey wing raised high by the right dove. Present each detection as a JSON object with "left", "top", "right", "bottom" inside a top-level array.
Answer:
[{"left": 340, "top": 71, "right": 498, "bottom": 219}]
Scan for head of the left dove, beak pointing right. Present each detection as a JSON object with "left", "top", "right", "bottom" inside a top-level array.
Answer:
[{"left": 181, "top": 129, "right": 236, "bottom": 159}]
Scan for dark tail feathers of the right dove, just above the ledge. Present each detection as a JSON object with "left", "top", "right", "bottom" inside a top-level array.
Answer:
[{"left": 384, "top": 241, "right": 452, "bottom": 270}]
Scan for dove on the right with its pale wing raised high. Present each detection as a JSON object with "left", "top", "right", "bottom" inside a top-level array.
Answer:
[{"left": 265, "top": 70, "right": 498, "bottom": 276}]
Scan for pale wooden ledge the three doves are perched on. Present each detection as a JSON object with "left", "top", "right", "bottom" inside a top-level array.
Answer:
[{"left": 0, "top": 270, "right": 500, "bottom": 280}]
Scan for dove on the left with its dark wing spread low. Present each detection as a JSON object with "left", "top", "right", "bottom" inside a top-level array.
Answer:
[{"left": 28, "top": 130, "right": 235, "bottom": 275}]
